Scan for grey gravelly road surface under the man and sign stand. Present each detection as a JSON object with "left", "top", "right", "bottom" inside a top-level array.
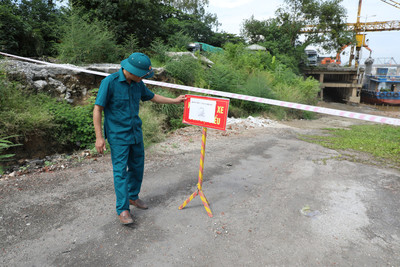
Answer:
[{"left": 0, "top": 112, "right": 400, "bottom": 266}]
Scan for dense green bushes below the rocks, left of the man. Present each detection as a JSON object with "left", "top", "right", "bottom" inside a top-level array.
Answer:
[{"left": 0, "top": 69, "right": 95, "bottom": 150}]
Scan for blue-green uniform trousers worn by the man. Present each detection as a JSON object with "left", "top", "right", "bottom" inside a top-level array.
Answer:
[{"left": 110, "top": 142, "right": 144, "bottom": 215}]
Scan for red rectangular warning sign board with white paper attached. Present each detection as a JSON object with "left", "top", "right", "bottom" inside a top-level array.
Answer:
[{"left": 182, "top": 95, "right": 229, "bottom": 131}]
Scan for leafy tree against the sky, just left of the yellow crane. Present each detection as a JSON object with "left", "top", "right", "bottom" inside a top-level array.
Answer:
[{"left": 242, "top": 0, "right": 353, "bottom": 58}]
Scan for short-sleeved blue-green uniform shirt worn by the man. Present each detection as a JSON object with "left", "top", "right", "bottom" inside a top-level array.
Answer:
[{"left": 95, "top": 68, "right": 154, "bottom": 145}]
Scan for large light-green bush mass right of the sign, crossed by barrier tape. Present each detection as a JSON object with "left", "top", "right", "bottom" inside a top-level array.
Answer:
[{"left": 205, "top": 43, "right": 320, "bottom": 119}]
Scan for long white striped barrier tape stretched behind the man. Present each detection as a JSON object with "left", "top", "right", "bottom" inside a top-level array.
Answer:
[{"left": 0, "top": 52, "right": 400, "bottom": 126}]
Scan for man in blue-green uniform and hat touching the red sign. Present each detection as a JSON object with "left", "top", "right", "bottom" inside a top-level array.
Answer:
[{"left": 93, "top": 53, "right": 185, "bottom": 224}]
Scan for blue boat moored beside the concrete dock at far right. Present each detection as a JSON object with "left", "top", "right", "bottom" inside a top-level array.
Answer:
[{"left": 361, "top": 68, "right": 400, "bottom": 105}]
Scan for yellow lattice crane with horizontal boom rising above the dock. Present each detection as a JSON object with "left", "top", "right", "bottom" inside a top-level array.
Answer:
[{"left": 300, "top": 0, "right": 400, "bottom": 66}]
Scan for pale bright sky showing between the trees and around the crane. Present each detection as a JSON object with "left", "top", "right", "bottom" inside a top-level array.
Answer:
[{"left": 207, "top": 0, "right": 400, "bottom": 64}]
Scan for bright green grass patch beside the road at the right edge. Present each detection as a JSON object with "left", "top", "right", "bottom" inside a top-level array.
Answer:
[{"left": 300, "top": 125, "right": 400, "bottom": 169}]
